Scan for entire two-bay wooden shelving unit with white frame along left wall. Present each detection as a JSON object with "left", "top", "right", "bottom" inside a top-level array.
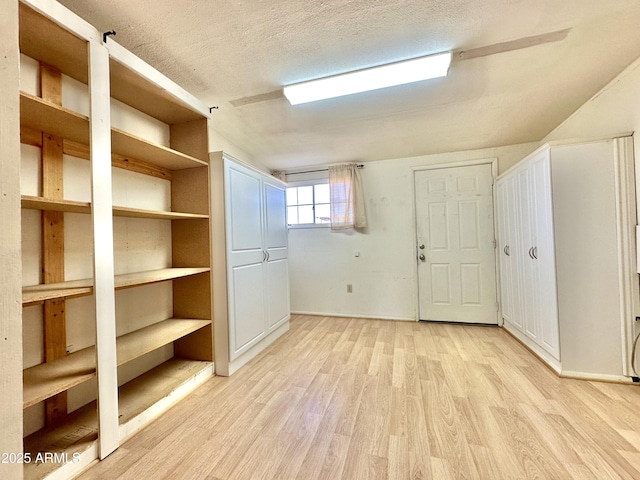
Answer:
[{"left": 15, "top": 0, "right": 214, "bottom": 478}]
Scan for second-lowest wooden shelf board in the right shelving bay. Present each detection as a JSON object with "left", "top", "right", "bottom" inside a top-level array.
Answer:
[{"left": 117, "top": 318, "right": 211, "bottom": 365}]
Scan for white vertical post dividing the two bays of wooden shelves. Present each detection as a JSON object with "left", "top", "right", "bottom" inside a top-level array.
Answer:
[{"left": 89, "top": 41, "right": 119, "bottom": 459}]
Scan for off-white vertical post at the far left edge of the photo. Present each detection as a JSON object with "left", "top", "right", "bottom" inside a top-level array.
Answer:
[{"left": 0, "top": 0, "right": 23, "bottom": 479}]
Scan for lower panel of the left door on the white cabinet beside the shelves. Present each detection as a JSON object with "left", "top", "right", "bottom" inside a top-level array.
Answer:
[{"left": 229, "top": 263, "right": 265, "bottom": 360}]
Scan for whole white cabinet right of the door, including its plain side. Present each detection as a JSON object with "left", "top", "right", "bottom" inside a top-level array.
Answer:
[{"left": 497, "top": 137, "right": 638, "bottom": 379}]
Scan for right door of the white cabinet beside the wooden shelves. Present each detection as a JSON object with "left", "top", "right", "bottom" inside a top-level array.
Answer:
[{"left": 263, "top": 178, "right": 290, "bottom": 331}]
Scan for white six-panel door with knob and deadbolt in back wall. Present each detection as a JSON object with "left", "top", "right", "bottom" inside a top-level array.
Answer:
[{"left": 414, "top": 164, "right": 498, "bottom": 324}]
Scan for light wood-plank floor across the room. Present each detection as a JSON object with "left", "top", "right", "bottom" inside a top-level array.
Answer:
[{"left": 81, "top": 316, "right": 640, "bottom": 480}]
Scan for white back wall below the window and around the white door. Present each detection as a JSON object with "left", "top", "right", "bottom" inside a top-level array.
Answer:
[{"left": 289, "top": 143, "right": 538, "bottom": 320}]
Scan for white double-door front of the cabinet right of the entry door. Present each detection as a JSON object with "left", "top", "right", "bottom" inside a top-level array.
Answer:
[{"left": 497, "top": 150, "right": 560, "bottom": 360}]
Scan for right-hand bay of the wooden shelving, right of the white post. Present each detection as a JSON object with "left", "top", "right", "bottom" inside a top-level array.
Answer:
[{"left": 107, "top": 6, "right": 214, "bottom": 454}]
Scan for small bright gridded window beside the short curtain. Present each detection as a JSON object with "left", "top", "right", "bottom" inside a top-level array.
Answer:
[{"left": 287, "top": 183, "right": 331, "bottom": 226}]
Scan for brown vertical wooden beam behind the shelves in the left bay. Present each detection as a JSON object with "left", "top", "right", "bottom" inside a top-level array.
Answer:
[{"left": 40, "top": 63, "right": 67, "bottom": 426}]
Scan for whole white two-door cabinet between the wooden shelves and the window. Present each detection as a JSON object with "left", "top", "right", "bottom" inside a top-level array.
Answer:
[{"left": 211, "top": 153, "right": 290, "bottom": 375}]
